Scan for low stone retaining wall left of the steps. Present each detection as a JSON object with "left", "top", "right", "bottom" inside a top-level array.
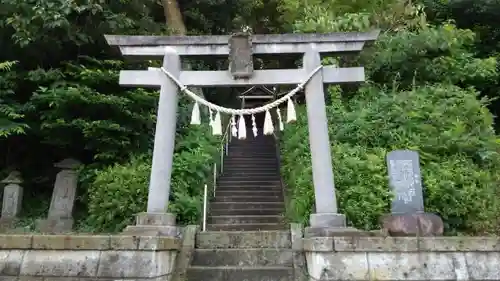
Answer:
[{"left": 0, "top": 235, "right": 181, "bottom": 281}]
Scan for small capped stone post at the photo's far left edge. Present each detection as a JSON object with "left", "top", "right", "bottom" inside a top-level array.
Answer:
[{"left": 0, "top": 171, "right": 23, "bottom": 227}]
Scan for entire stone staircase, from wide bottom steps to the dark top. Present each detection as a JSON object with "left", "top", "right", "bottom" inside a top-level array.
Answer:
[{"left": 186, "top": 130, "right": 294, "bottom": 281}]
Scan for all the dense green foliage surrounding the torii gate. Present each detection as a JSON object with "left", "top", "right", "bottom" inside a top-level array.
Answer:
[{"left": 0, "top": 0, "right": 500, "bottom": 233}]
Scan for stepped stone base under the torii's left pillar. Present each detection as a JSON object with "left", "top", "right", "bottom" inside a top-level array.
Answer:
[{"left": 123, "top": 213, "right": 182, "bottom": 237}]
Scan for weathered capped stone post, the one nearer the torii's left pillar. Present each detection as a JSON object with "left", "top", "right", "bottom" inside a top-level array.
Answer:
[{"left": 37, "top": 159, "right": 81, "bottom": 233}]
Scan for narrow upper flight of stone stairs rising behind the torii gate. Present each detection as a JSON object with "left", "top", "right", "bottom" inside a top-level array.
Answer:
[{"left": 207, "top": 130, "right": 287, "bottom": 231}]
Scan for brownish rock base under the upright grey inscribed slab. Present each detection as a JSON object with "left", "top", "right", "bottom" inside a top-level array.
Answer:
[{"left": 382, "top": 213, "right": 444, "bottom": 236}]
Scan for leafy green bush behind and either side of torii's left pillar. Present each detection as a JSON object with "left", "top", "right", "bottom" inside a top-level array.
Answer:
[{"left": 85, "top": 125, "right": 218, "bottom": 232}]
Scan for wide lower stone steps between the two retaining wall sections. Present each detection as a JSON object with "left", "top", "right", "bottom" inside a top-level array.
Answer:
[{"left": 187, "top": 231, "right": 294, "bottom": 281}]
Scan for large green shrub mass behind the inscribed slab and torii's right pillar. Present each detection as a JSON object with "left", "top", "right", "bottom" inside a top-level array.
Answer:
[{"left": 281, "top": 85, "right": 499, "bottom": 233}]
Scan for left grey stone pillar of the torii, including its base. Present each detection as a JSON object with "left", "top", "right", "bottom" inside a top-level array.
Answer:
[{"left": 124, "top": 47, "right": 181, "bottom": 236}]
